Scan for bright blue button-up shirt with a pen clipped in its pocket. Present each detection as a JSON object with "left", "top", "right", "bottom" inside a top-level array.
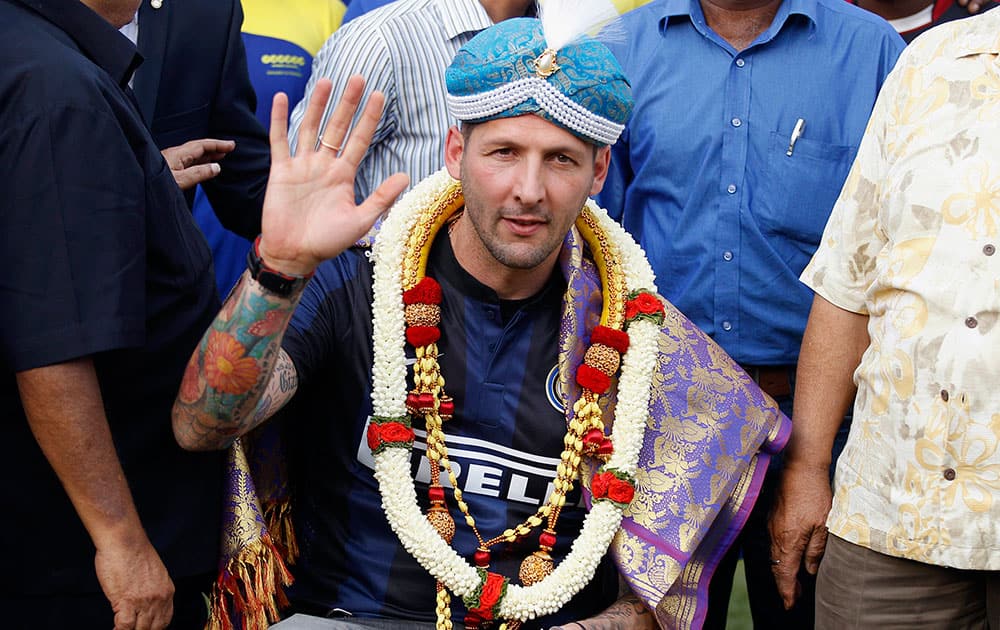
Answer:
[{"left": 599, "top": 0, "right": 903, "bottom": 365}]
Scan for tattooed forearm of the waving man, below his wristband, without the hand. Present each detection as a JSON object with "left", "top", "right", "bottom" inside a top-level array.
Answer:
[{"left": 173, "top": 274, "right": 300, "bottom": 450}]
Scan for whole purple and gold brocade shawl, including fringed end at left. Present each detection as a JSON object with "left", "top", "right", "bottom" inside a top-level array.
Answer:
[{"left": 209, "top": 229, "right": 791, "bottom": 630}]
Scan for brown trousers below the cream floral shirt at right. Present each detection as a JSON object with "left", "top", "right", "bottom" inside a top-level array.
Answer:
[{"left": 816, "top": 535, "right": 1000, "bottom": 630}]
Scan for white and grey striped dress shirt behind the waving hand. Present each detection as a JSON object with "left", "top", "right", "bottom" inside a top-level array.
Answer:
[{"left": 291, "top": 0, "right": 492, "bottom": 201}]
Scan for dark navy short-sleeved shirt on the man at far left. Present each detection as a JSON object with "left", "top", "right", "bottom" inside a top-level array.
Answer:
[{"left": 0, "top": 0, "right": 223, "bottom": 595}]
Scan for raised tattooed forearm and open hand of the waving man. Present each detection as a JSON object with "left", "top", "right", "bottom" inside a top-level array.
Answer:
[{"left": 173, "top": 77, "right": 407, "bottom": 450}]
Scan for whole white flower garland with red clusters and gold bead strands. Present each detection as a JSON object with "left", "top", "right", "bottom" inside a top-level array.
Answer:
[{"left": 369, "top": 170, "right": 663, "bottom": 627}]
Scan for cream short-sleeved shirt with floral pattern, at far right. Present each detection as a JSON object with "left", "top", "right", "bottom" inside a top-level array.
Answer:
[{"left": 802, "top": 10, "right": 1000, "bottom": 570}]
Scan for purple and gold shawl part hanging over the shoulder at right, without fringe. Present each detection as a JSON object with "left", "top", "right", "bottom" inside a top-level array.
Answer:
[{"left": 559, "top": 232, "right": 791, "bottom": 628}]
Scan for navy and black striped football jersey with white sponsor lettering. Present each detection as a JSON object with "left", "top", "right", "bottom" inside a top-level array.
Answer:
[{"left": 284, "top": 237, "right": 618, "bottom": 627}]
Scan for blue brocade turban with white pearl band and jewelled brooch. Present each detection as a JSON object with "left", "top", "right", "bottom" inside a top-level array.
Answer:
[{"left": 445, "top": 18, "right": 632, "bottom": 146}]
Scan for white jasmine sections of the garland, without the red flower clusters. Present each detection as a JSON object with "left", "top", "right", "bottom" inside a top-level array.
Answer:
[{"left": 372, "top": 169, "right": 659, "bottom": 621}]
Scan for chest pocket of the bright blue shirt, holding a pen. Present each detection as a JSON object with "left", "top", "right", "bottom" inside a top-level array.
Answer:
[{"left": 751, "top": 129, "right": 857, "bottom": 248}]
